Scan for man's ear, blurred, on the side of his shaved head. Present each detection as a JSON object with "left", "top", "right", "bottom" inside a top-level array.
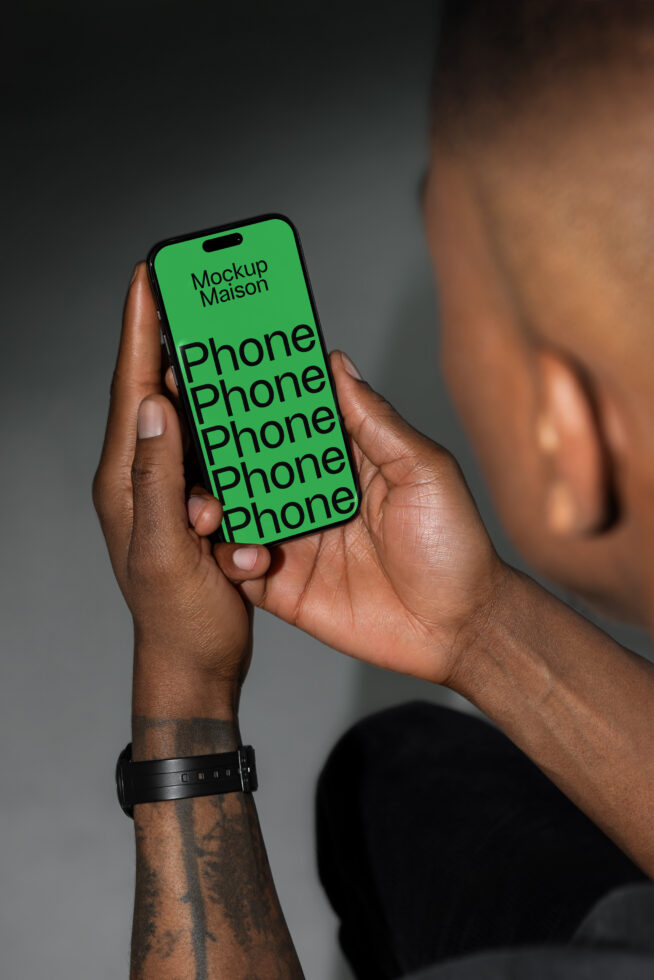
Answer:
[{"left": 536, "top": 349, "right": 614, "bottom": 536}]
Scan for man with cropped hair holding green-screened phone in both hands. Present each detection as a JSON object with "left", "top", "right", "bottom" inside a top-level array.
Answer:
[{"left": 93, "top": 0, "right": 654, "bottom": 980}]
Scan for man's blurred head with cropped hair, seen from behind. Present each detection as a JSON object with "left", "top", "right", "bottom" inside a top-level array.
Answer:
[{"left": 424, "top": 0, "right": 654, "bottom": 625}]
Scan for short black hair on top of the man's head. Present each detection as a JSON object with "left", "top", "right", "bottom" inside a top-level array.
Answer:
[{"left": 432, "top": 0, "right": 654, "bottom": 149}]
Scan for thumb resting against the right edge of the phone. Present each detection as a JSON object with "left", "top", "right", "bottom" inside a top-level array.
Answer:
[{"left": 330, "top": 350, "right": 444, "bottom": 467}]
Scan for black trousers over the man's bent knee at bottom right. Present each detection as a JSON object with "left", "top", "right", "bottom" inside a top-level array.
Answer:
[{"left": 316, "top": 701, "right": 654, "bottom": 980}]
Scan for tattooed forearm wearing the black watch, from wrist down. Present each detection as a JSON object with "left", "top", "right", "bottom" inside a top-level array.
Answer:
[{"left": 131, "top": 675, "right": 303, "bottom": 980}]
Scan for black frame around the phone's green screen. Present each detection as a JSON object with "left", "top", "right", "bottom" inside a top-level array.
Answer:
[{"left": 146, "top": 212, "right": 362, "bottom": 548}]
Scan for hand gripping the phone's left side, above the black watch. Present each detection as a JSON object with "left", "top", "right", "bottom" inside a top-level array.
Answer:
[{"left": 93, "top": 263, "right": 270, "bottom": 717}]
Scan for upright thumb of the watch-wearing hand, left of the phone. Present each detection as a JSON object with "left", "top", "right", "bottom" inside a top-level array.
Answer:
[{"left": 132, "top": 395, "right": 195, "bottom": 557}]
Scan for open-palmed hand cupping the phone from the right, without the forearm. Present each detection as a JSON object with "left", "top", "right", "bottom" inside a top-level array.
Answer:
[{"left": 216, "top": 351, "right": 508, "bottom": 684}]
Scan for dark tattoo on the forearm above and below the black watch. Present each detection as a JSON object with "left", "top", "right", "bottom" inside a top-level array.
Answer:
[{"left": 132, "top": 716, "right": 303, "bottom": 980}]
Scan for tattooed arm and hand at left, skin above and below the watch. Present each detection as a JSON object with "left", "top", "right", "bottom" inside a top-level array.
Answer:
[{"left": 93, "top": 266, "right": 302, "bottom": 980}]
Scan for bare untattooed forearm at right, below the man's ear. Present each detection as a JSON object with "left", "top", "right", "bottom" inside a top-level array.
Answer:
[{"left": 452, "top": 572, "right": 654, "bottom": 876}]
